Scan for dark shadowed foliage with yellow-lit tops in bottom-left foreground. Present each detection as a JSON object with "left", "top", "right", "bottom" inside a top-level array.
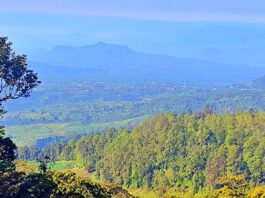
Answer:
[{"left": 0, "top": 171, "right": 133, "bottom": 198}]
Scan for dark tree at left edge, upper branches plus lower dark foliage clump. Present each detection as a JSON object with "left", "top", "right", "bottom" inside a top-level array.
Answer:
[{"left": 0, "top": 37, "right": 40, "bottom": 189}]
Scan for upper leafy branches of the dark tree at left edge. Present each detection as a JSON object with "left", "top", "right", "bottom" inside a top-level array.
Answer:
[{"left": 0, "top": 37, "right": 40, "bottom": 115}]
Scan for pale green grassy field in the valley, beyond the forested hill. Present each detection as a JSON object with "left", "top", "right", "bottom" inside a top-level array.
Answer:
[{"left": 6, "top": 117, "right": 146, "bottom": 146}]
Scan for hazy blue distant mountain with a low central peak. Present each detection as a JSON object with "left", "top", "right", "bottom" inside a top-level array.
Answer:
[{"left": 29, "top": 42, "right": 265, "bottom": 86}]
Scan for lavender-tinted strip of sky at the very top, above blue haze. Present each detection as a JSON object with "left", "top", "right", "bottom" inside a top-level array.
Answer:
[{"left": 0, "top": 0, "right": 265, "bottom": 22}]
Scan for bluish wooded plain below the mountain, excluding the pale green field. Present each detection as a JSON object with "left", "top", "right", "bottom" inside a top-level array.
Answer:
[{"left": 3, "top": 84, "right": 265, "bottom": 126}]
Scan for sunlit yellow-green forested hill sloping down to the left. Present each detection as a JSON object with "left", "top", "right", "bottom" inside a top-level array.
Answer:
[{"left": 20, "top": 109, "right": 265, "bottom": 196}]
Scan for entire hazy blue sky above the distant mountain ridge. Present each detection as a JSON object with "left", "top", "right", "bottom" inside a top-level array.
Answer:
[{"left": 0, "top": 0, "right": 265, "bottom": 66}]
